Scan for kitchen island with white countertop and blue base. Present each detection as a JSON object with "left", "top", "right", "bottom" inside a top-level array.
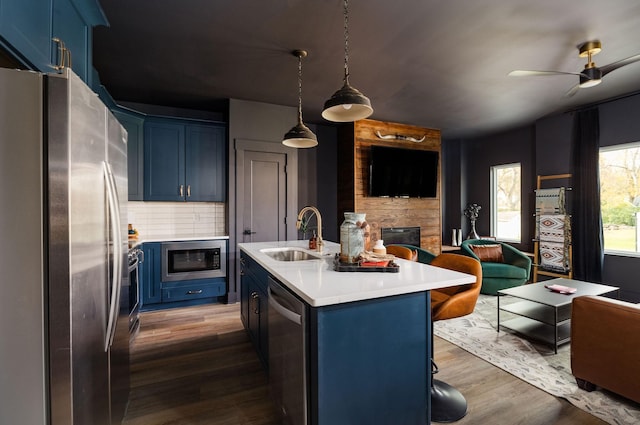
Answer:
[{"left": 238, "top": 241, "right": 475, "bottom": 425}]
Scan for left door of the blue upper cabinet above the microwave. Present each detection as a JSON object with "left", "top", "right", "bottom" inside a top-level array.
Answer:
[{"left": 144, "top": 120, "right": 187, "bottom": 201}]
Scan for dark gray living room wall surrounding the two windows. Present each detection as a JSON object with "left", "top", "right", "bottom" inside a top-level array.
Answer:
[{"left": 443, "top": 94, "right": 640, "bottom": 302}]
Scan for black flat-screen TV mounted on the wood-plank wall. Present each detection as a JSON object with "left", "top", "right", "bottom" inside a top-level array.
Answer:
[{"left": 369, "top": 145, "right": 438, "bottom": 198}]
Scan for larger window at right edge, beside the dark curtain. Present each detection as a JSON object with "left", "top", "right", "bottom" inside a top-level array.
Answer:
[{"left": 600, "top": 143, "right": 640, "bottom": 254}]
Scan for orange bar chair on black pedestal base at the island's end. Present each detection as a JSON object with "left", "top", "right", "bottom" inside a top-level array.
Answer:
[{"left": 431, "top": 254, "right": 482, "bottom": 422}]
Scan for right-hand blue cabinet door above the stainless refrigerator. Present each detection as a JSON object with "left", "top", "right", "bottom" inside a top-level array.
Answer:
[{"left": 51, "top": 0, "right": 91, "bottom": 84}]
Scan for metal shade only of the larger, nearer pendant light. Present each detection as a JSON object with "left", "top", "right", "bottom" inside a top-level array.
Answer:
[{"left": 322, "top": 81, "right": 373, "bottom": 122}]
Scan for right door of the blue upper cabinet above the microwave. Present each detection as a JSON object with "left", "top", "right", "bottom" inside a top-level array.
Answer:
[{"left": 185, "top": 125, "right": 226, "bottom": 202}]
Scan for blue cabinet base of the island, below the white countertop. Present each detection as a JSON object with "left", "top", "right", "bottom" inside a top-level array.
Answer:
[{"left": 241, "top": 252, "right": 431, "bottom": 425}]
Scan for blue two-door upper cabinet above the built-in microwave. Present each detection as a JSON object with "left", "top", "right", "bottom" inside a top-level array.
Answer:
[{"left": 144, "top": 118, "right": 226, "bottom": 202}]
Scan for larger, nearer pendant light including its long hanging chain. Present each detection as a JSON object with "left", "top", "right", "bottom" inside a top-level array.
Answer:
[{"left": 322, "top": 0, "right": 373, "bottom": 122}]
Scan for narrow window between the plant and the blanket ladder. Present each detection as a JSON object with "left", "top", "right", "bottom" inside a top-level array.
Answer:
[{"left": 491, "top": 163, "right": 522, "bottom": 243}]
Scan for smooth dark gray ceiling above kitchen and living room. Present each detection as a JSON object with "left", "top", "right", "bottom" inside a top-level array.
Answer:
[{"left": 94, "top": 0, "right": 640, "bottom": 138}]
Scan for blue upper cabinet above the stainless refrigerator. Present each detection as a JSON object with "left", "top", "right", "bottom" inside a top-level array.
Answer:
[{"left": 0, "top": 0, "right": 108, "bottom": 87}]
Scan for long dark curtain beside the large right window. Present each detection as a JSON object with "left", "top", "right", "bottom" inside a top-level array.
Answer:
[{"left": 571, "top": 108, "right": 604, "bottom": 283}]
